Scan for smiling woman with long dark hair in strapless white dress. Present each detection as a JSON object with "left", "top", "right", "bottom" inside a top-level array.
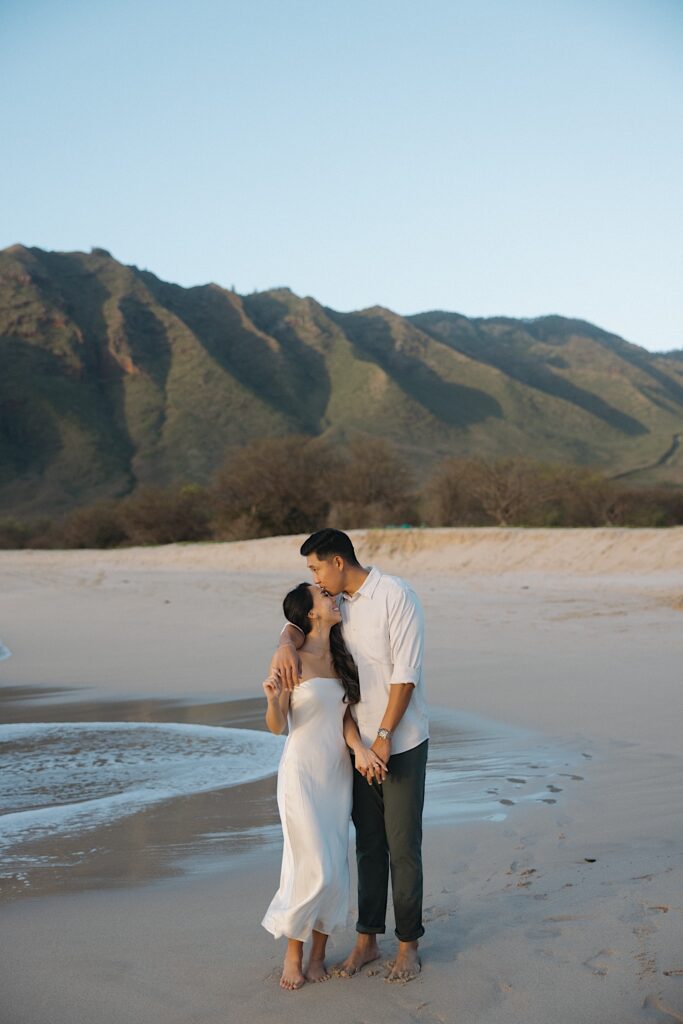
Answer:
[{"left": 262, "top": 583, "right": 386, "bottom": 990}]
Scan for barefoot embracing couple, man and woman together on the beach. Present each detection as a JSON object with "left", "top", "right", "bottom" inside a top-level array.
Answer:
[{"left": 262, "top": 529, "right": 429, "bottom": 989}]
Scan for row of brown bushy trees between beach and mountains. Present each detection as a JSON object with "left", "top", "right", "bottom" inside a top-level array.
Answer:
[{"left": 0, "top": 436, "right": 683, "bottom": 548}]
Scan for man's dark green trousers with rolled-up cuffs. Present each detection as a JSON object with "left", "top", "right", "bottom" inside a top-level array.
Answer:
[{"left": 351, "top": 739, "right": 429, "bottom": 942}]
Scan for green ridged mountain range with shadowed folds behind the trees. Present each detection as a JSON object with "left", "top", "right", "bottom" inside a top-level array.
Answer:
[{"left": 0, "top": 238, "right": 683, "bottom": 514}]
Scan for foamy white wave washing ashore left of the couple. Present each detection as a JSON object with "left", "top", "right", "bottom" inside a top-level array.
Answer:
[{"left": 0, "top": 722, "right": 285, "bottom": 865}]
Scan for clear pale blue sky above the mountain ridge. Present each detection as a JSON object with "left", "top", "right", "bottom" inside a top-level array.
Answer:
[{"left": 0, "top": 0, "right": 683, "bottom": 350}]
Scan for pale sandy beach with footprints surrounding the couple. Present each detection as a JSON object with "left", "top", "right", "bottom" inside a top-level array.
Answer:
[{"left": 0, "top": 528, "right": 683, "bottom": 1024}]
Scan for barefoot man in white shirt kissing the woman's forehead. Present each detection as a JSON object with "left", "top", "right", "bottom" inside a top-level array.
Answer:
[{"left": 271, "top": 529, "right": 429, "bottom": 982}]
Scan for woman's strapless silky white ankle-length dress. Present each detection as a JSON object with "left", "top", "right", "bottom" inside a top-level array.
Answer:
[{"left": 261, "top": 676, "right": 353, "bottom": 942}]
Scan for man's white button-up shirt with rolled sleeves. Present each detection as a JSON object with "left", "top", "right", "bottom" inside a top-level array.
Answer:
[{"left": 339, "top": 567, "right": 429, "bottom": 754}]
